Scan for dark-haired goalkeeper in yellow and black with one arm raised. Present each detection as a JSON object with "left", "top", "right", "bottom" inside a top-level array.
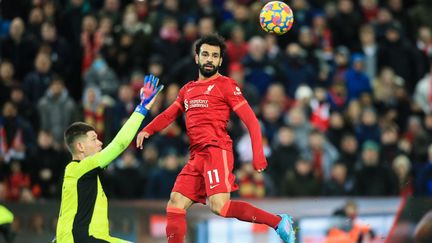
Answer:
[{"left": 56, "top": 75, "right": 163, "bottom": 243}]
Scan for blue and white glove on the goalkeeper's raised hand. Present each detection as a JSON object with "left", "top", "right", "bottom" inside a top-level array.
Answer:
[{"left": 135, "top": 74, "right": 164, "bottom": 116}]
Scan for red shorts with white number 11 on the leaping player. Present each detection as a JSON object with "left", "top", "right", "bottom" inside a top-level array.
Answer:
[{"left": 172, "top": 146, "right": 238, "bottom": 204}]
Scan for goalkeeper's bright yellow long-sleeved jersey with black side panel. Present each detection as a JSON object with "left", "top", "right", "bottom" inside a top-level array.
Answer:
[{"left": 56, "top": 112, "right": 144, "bottom": 243}]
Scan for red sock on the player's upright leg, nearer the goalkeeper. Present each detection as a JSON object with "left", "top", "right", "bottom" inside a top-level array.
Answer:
[{"left": 166, "top": 208, "right": 186, "bottom": 243}]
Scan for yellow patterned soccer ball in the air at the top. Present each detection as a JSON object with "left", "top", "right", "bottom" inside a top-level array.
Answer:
[{"left": 260, "top": 1, "right": 294, "bottom": 35}]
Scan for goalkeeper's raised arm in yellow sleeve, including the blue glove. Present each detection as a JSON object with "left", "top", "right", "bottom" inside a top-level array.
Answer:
[{"left": 92, "top": 75, "right": 163, "bottom": 168}]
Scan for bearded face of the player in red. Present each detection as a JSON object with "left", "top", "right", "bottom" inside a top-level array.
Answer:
[{"left": 195, "top": 44, "right": 222, "bottom": 78}]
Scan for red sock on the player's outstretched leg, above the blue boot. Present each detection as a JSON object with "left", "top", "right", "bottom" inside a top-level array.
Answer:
[{"left": 220, "top": 200, "right": 281, "bottom": 228}]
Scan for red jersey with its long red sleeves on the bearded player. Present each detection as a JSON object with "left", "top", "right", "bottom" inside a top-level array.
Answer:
[{"left": 143, "top": 75, "right": 267, "bottom": 169}]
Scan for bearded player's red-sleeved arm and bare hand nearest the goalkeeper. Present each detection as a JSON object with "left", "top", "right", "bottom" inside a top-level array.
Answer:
[{"left": 136, "top": 88, "right": 184, "bottom": 149}]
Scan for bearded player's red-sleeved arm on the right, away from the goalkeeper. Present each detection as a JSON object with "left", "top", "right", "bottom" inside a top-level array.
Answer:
[{"left": 224, "top": 80, "right": 267, "bottom": 172}]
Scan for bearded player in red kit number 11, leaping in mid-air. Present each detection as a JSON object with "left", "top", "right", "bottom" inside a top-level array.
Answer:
[{"left": 137, "top": 35, "right": 295, "bottom": 243}]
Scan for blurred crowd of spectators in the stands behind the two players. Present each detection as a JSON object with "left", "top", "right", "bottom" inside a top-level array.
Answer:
[{"left": 0, "top": 0, "right": 432, "bottom": 201}]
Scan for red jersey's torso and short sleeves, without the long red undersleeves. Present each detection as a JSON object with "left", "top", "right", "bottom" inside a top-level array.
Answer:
[{"left": 176, "top": 75, "right": 247, "bottom": 151}]
